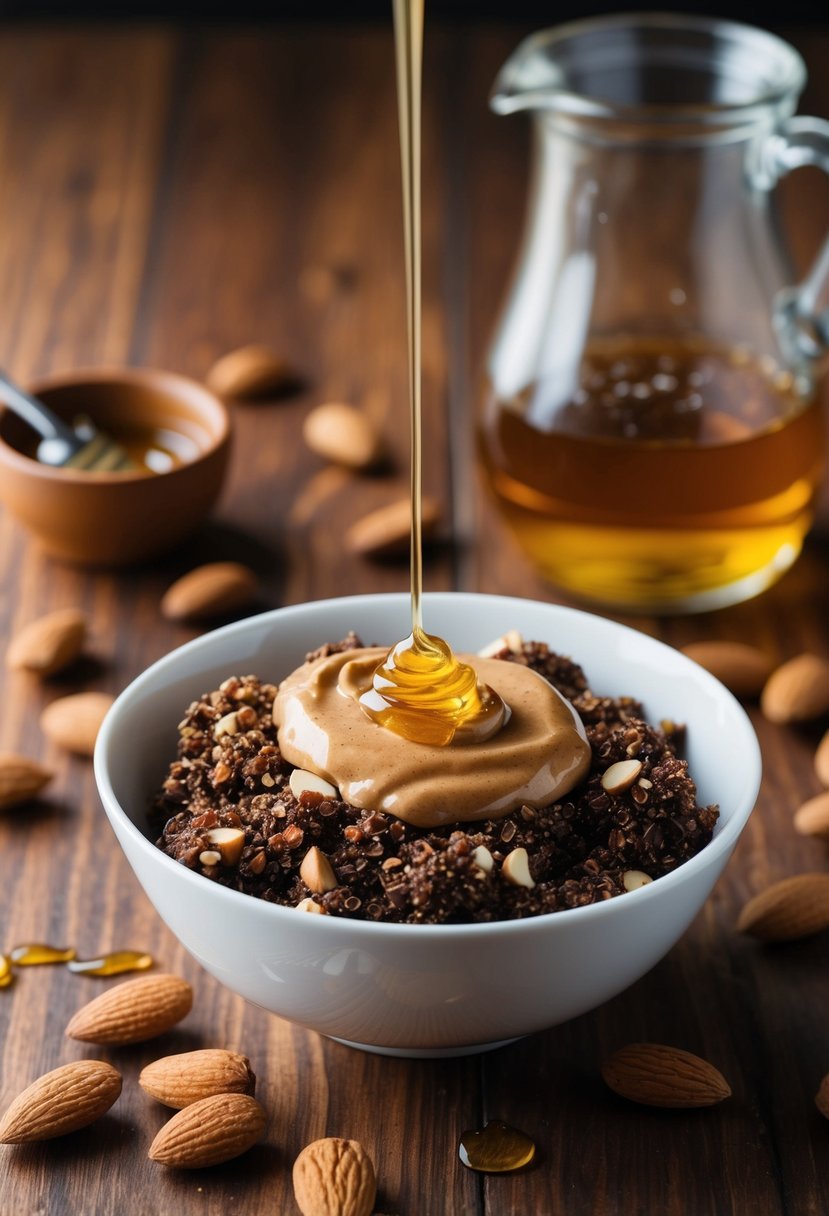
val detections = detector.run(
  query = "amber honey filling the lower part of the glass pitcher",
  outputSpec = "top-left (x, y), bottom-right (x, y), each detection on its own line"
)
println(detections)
top-left (480, 338), bottom-right (823, 610)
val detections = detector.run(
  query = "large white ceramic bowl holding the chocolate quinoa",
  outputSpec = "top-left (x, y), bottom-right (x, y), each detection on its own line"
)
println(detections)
top-left (95, 593), bottom-right (760, 1055)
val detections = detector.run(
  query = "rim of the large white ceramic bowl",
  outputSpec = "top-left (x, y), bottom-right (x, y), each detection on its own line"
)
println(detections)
top-left (94, 591), bottom-right (762, 944)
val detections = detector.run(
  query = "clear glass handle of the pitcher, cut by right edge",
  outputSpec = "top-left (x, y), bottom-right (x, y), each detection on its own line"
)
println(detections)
top-left (758, 114), bottom-right (829, 362)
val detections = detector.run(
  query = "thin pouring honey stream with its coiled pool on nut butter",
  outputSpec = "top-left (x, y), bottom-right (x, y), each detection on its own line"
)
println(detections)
top-left (360, 0), bottom-right (508, 745)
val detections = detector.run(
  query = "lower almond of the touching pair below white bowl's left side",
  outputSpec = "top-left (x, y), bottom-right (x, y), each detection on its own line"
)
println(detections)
top-left (148, 1093), bottom-right (267, 1170)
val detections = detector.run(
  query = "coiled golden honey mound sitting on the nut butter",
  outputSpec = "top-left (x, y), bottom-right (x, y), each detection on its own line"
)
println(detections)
top-left (360, 627), bottom-right (507, 747)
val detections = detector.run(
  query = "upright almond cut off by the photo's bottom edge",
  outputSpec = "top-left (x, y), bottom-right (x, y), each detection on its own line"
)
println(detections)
top-left (293, 1136), bottom-right (377, 1216)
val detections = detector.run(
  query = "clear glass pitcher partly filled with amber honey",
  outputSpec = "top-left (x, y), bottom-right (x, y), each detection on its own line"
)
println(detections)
top-left (479, 13), bottom-right (829, 612)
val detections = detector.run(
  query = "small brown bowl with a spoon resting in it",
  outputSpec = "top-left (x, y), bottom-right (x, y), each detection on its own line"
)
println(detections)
top-left (0, 367), bottom-right (230, 567)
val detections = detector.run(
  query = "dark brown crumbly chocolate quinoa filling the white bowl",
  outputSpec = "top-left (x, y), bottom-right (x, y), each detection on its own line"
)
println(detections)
top-left (151, 634), bottom-right (718, 924)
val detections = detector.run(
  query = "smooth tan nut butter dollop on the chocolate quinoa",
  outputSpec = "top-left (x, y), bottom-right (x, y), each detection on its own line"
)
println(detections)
top-left (273, 647), bottom-right (591, 828)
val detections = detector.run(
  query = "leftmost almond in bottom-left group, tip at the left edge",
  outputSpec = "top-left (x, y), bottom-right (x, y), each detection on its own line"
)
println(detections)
top-left (0, 1060), bottom-right (122, 1144)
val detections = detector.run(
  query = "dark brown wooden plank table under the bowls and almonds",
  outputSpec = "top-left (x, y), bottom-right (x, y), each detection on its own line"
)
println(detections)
top-left (0, 26), bottom-right (829, 1216)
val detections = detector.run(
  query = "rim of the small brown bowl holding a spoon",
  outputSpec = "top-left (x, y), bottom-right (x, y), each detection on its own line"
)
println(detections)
top-left (0, 364), bottom-right (231, 486)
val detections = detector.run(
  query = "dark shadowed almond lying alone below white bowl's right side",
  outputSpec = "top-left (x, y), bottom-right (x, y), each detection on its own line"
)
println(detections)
top-left (602, 1043), bottom-right (731, 1108)
